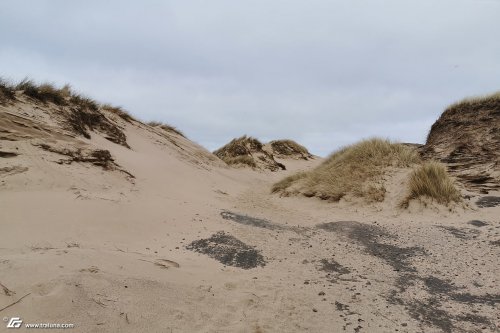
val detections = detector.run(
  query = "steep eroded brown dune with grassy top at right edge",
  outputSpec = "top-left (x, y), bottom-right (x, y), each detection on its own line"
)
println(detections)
top-left (424, 93), bottom-right (500, 194)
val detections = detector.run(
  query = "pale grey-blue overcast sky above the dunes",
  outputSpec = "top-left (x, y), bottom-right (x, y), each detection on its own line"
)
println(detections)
top-left (0, 0), bottom-right (500, 155)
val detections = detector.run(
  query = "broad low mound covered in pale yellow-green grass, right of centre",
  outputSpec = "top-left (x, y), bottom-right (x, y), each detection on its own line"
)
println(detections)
top-left (271, 138), bottom-right (421, 202)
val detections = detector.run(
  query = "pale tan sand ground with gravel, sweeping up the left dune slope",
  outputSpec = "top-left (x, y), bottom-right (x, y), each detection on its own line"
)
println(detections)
top-left (0, 100), bottom-right (500, 333)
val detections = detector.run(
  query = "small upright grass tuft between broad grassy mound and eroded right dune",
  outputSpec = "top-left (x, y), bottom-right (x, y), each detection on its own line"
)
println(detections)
top-left (401, 161), bottom-right (461, 207)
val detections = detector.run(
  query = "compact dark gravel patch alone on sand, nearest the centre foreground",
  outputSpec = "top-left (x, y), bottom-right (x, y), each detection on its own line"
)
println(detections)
top-left (186, 231), bottom-right (266, 269)
